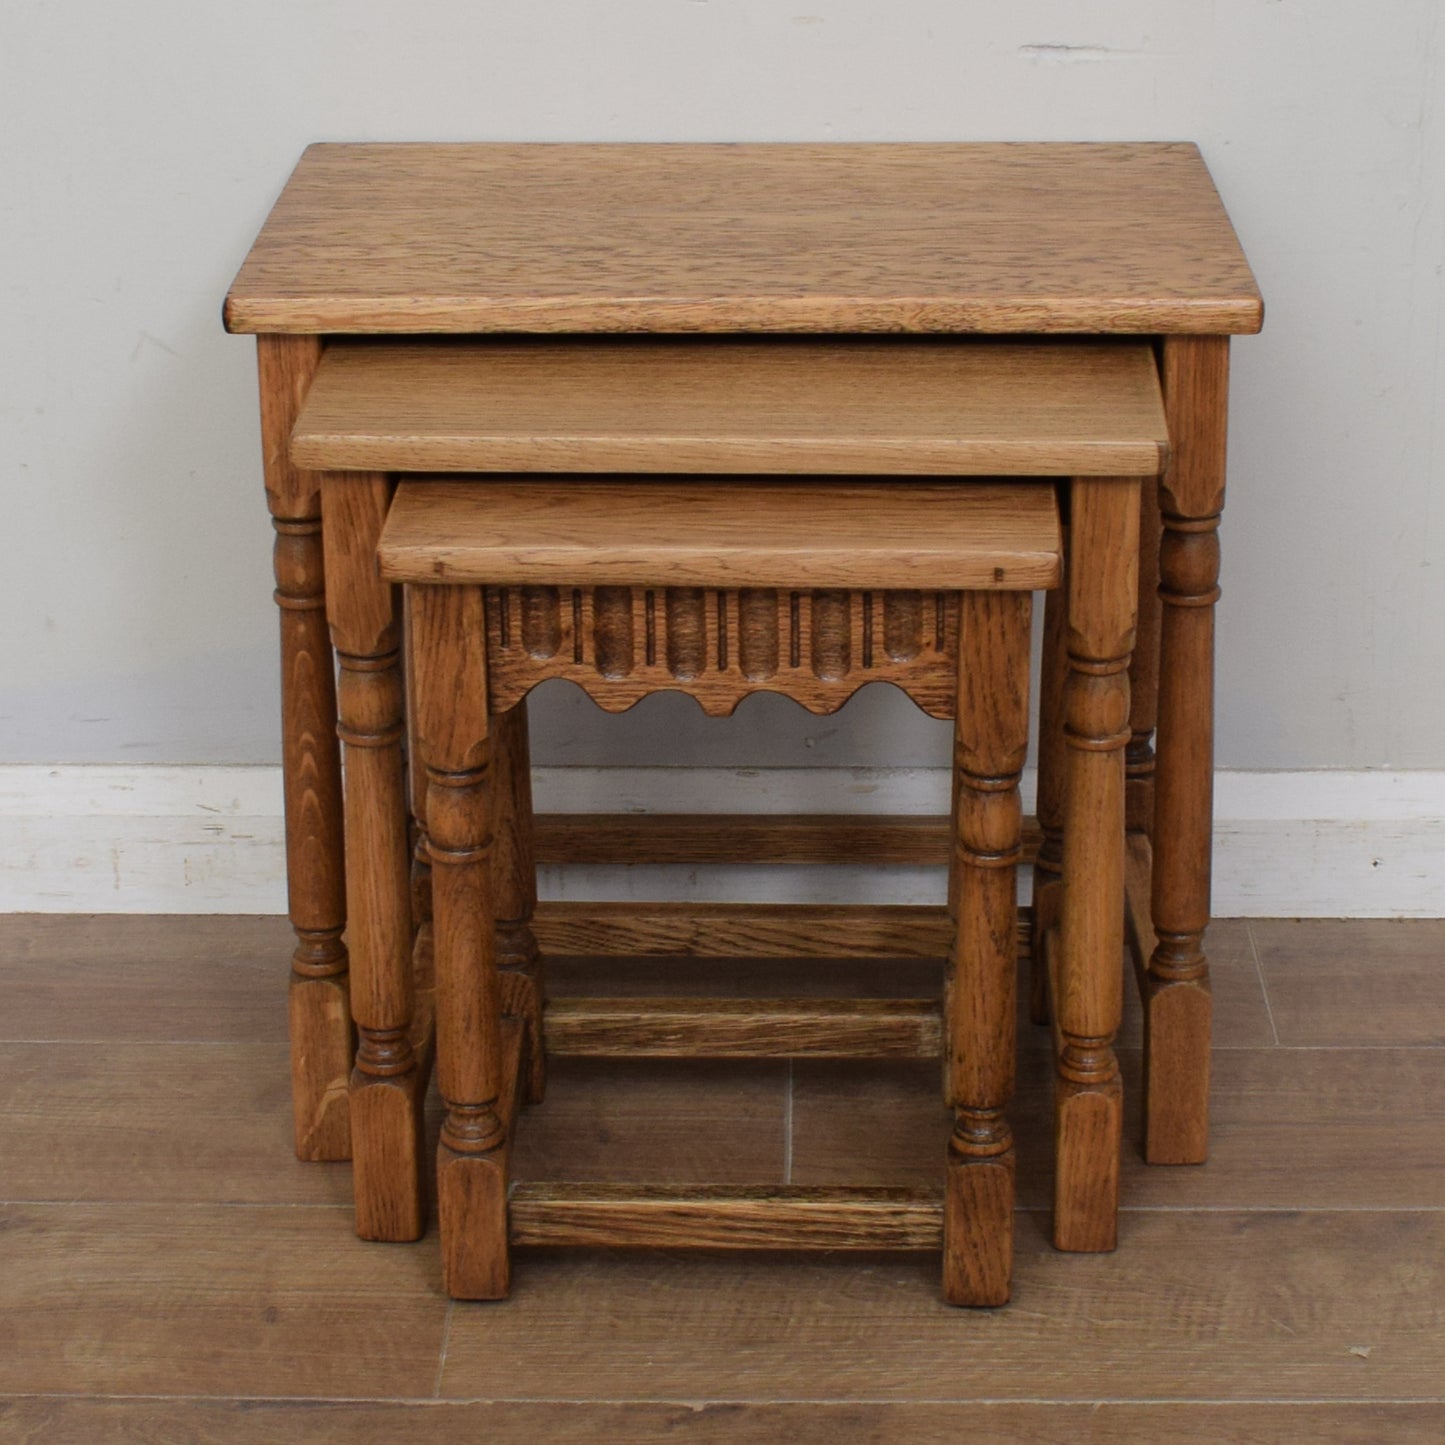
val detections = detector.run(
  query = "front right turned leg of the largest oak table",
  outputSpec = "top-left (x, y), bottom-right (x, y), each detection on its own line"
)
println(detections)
top-left (1144, 337), bottom-right (1230, 1163)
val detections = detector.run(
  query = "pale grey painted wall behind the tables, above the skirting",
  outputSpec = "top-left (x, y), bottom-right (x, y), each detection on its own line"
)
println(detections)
top-left (0, 0), bottom-right (1445, 769)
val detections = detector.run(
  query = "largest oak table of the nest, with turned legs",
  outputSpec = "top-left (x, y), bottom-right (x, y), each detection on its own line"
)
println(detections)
top-left (225, 143), bottom-right (1263, 1248)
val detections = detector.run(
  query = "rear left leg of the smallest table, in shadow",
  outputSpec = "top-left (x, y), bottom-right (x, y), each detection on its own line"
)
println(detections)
top-left (491, 699), bottom-right (546, 1104)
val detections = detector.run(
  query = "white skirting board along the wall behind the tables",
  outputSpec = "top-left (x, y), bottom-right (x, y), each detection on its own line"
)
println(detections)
top-left (0, 766), bottom-right (1445, 918)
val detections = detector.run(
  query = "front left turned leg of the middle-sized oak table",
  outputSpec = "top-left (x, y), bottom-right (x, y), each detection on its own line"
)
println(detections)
top-left (322, 473), bottom-right (425, 1240)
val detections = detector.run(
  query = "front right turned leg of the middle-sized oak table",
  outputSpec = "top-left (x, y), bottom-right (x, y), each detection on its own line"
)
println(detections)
top-left (1053, 477), bottom-right (1139, 1250)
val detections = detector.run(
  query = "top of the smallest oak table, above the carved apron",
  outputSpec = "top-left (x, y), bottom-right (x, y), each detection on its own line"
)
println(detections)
top-left (379, 478), bottom-right (1061, 592)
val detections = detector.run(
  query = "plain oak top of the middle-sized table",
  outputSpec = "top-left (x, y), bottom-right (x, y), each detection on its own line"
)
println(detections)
top-left (290, 338), bottom-right (1168, 476)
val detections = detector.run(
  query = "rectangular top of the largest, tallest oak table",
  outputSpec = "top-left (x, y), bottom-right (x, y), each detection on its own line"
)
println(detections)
top-left (225, 142), bottom-right (1263, 334)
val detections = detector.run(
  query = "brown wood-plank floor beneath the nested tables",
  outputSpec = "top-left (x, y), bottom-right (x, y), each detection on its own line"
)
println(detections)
top-left (0, 916), bottom-right (1445, 1445)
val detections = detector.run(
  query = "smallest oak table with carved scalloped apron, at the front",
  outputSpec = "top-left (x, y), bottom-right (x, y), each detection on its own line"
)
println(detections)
top-left (395, 481), bottom-right (1061, 1305)
